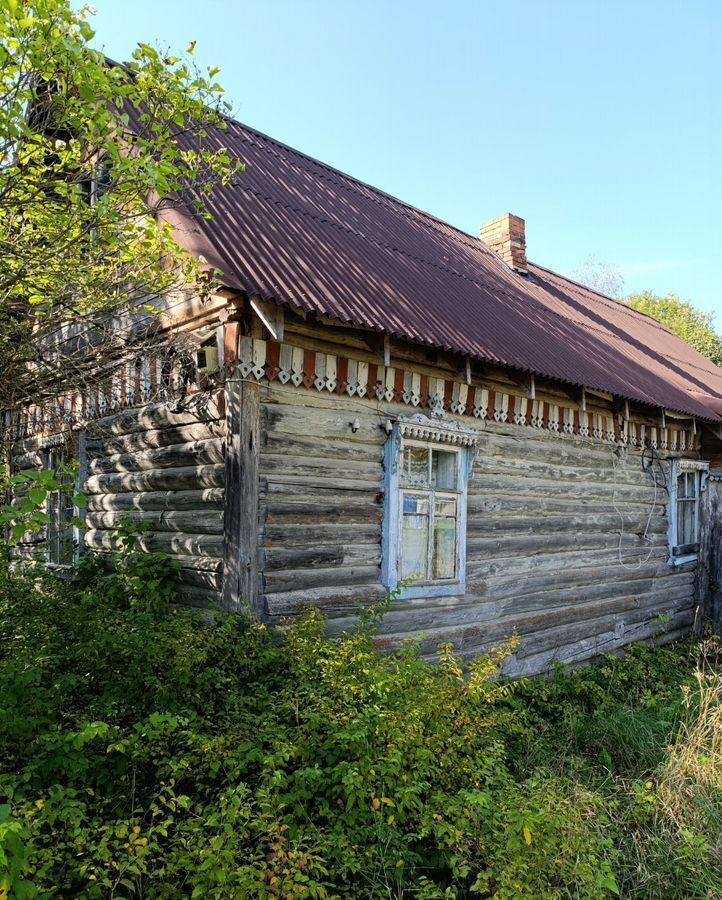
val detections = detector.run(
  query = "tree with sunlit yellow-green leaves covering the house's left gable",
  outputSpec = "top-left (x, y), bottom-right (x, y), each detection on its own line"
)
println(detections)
top-left (0, 0), bottom-right (242, 418)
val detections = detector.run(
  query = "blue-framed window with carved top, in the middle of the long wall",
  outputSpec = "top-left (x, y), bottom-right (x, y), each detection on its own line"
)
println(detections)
top-left (383, 416), bottom-right (478, 597)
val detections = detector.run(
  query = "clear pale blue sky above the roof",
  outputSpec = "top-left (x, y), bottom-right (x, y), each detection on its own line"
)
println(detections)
top-left (81, 0), bottom-right (722, 327)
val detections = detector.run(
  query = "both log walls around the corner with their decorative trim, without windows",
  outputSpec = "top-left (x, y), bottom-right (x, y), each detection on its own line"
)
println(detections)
top-left (5, 307), bottom-right (699, 674)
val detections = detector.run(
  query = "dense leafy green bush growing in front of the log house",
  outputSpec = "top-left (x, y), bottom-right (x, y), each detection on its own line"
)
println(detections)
top-left (0, 546), bottom-right (615, 900)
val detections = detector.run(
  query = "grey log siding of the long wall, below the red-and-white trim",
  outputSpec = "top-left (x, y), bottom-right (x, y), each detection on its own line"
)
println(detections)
top-left (258, 384), bottom-right (694, 673)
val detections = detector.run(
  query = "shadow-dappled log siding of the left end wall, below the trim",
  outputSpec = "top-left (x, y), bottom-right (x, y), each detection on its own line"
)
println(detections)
top-left (85, 392), bottom-right (226, 604)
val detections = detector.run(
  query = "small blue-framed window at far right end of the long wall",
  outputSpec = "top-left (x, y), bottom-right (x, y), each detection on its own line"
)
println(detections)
top-left (669, 459), bottom-right (709, 566)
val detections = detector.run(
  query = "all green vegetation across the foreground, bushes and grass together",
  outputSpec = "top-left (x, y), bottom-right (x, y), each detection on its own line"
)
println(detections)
top-left (0, 529), bottom-right (722, 900)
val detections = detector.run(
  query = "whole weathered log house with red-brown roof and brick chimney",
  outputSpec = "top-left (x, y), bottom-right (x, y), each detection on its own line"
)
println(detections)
top-left (6, 116), bottom-right (722, 673)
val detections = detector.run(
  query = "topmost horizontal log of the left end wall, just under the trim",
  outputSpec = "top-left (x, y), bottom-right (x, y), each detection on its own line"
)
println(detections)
top-left (87, 391), bottom-right (225, 441)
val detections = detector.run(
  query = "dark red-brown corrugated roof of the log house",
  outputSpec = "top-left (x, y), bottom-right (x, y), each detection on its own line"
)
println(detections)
top-left (170, 121), bottom-right (722, 421)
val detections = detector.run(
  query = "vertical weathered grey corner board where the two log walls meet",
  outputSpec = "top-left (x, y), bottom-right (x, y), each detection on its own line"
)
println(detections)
top-left (223, 378), bottom-right (262, 616)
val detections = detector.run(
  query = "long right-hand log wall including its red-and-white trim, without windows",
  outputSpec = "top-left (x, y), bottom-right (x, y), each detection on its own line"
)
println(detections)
top-left (248, 314), bottom-right (699, 674)
